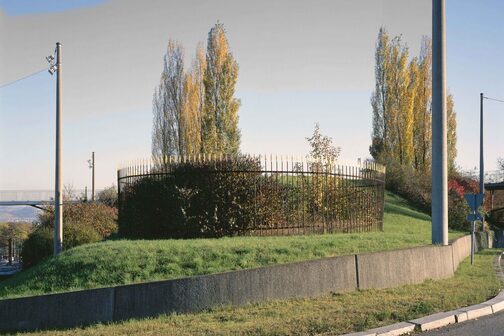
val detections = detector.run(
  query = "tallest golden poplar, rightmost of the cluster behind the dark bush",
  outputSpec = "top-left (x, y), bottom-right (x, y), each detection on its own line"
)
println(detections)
top-left (202, 23), bottom-right (240, 154)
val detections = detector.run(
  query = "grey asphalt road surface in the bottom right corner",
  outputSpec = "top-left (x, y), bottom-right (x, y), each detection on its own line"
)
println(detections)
top-left (421, 312), bottom-right (504, 336)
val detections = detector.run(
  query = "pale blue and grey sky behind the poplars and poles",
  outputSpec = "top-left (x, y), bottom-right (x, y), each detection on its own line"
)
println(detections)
top-left (0, 0), bottom-right (504, 190)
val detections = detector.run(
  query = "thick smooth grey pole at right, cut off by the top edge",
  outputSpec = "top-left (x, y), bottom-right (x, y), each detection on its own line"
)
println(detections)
top-left (432, 0), bottom-right (448, 245)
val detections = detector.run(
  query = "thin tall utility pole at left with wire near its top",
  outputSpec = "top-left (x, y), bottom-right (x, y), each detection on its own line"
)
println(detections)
top-left (54, 42), bottom-right (63, 255)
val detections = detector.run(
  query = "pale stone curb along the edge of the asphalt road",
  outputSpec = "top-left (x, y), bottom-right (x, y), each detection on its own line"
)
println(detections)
top-left (342, 252), bottom-right (504, 336)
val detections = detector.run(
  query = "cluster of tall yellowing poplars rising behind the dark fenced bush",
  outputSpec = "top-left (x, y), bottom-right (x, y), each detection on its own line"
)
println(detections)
top-left (152, 23), bottom-right (240, 165)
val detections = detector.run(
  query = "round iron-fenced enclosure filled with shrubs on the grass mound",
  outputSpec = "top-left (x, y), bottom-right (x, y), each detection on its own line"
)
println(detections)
top-left (118, 155), bottom-right (385, 238)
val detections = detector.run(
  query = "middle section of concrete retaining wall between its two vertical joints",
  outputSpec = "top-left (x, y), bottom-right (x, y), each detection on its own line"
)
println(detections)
top-left (114, 256), bottom-right (357, 320)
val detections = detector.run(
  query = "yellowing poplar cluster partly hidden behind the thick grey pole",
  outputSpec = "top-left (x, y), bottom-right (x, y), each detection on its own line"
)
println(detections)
top-left (370, 28), bottom-right (457, 173)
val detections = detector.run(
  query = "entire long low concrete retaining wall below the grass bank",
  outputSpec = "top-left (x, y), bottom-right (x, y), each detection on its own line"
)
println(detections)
top-left (0, 236), bottom-right (478, 332)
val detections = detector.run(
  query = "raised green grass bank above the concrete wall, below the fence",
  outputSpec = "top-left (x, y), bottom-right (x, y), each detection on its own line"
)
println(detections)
top-left (0, 193), bottom-right (463, 298)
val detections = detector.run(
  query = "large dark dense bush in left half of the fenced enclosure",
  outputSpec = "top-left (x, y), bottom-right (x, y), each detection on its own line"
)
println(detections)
top-left (119, 157), bottom-right (267, 238)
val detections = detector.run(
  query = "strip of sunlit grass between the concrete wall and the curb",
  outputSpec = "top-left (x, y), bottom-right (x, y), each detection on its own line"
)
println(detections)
top-left (13, 250), bottom-right (502, 336)
